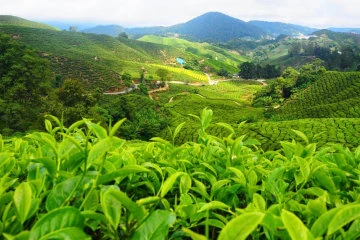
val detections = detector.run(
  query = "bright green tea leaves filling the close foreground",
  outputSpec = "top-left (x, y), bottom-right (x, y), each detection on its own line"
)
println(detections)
top-left (0, 109), bottom-right (360, 239)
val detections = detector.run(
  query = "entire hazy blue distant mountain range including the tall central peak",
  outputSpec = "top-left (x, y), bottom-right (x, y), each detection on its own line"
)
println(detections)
top-left (79, 12), bottom-right (360, 42)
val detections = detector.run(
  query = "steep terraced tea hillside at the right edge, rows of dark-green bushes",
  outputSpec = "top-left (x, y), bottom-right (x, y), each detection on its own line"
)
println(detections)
top-left (278, 71), bottom-right (360, 119)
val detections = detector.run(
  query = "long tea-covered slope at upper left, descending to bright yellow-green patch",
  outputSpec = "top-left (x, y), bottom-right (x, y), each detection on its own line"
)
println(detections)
top-left (0, 19), bottom-right (225, 90)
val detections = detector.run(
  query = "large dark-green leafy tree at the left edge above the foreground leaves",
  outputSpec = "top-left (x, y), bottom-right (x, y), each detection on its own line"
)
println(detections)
top-left (0, 34), bottom-right (51, 131)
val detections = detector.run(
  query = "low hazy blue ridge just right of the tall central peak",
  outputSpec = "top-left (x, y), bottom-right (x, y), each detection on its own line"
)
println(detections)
top-left (249, 20), bottom-right (318, 37)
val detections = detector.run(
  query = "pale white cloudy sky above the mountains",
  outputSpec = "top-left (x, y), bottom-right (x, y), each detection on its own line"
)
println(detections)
top-left (0, 0), bottom-right (360, 28)
